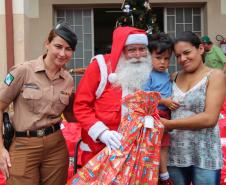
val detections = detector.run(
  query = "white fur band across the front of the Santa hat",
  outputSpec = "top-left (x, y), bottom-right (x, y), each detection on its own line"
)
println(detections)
top-left (125, 34), bottom-right (148, 46)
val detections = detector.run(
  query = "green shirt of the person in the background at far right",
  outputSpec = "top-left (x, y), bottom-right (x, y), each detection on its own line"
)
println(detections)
top-left (205, 45), bottom-right (226, 69)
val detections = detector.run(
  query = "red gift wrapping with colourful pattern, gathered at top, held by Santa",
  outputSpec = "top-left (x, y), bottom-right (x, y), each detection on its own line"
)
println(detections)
top-left (67, 91), bottom-right (163, 185)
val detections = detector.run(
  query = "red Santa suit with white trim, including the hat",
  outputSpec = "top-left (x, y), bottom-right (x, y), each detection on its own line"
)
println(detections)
top-left (73, 27), bottom-right (147, 165)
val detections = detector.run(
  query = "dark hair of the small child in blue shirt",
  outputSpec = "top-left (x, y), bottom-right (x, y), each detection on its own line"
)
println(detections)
top-left (148, 32), bottom-right (173, 54)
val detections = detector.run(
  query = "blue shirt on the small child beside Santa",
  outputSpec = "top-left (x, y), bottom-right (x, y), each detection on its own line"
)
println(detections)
top-left (143, 70), bottom-right (172, 110)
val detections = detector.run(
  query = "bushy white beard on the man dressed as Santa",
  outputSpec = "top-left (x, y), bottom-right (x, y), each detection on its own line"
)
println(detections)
top-left (115, 54), bottom-right (152, 93)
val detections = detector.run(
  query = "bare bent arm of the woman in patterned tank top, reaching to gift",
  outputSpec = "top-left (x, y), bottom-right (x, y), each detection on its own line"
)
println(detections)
top-left (161, 70), bottom-right (226, 130)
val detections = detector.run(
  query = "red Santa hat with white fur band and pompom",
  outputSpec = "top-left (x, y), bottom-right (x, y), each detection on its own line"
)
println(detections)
top-left (109, 26), bottom-right (148, 83)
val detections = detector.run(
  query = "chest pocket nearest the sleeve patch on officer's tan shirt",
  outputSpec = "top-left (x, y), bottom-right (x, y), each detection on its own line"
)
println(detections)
top-left (22, 88), bottom-right (42, 113)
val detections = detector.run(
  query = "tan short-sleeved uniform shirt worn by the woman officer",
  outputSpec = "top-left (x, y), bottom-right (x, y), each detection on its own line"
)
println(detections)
top-left (0, 56), bottom-right (74, 131)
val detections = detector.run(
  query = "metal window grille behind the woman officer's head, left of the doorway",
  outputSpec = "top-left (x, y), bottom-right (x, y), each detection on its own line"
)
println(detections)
top-left (54, 8), bottom-right (94, 87)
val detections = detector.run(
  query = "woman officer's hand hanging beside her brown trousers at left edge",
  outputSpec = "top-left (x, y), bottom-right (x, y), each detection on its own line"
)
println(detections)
top-left (0, 147), bottom-right (11, 179)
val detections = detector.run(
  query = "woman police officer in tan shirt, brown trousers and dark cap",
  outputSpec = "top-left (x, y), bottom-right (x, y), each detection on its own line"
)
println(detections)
top-left (0, 23), bottom-right (77, 185)
